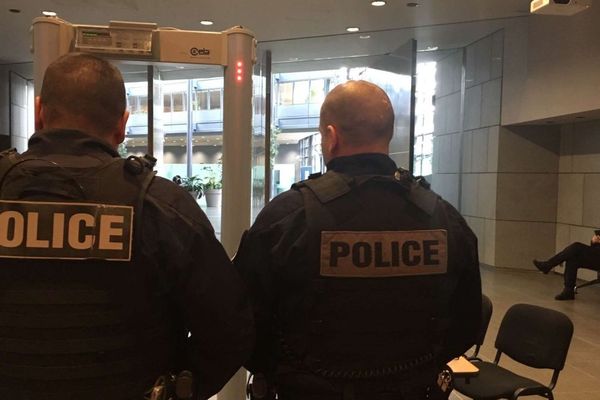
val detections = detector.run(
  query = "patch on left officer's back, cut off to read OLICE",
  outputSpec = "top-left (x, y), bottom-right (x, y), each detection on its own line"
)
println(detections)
top-left (0, 200), bottom-right (133, 261)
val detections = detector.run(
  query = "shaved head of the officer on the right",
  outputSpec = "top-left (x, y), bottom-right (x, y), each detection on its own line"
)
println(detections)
top-left (319, 81), bottom-right (394, 163)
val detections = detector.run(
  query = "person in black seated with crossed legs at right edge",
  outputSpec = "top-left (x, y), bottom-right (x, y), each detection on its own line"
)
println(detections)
top-left (533, 230), bottom-right (600, 300)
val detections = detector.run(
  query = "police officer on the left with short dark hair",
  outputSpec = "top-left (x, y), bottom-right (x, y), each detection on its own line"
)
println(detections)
top-left (0, 54), bottom-right (254, 400)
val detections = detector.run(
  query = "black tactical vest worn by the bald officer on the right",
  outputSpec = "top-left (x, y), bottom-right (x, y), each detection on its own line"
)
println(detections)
top-left (279, 171), bottom-right (451, 392)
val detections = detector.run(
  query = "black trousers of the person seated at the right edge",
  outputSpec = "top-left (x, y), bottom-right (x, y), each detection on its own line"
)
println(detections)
top-left (547, 242), bottom-right (600, 288)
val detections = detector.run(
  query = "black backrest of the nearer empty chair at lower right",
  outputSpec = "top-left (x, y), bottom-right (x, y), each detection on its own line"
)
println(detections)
top-left (495, 304), bottom-right (573, 371)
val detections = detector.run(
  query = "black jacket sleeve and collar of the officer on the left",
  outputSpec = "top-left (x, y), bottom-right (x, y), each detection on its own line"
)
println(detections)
top-left (15, 130), bottom-right (254, 398)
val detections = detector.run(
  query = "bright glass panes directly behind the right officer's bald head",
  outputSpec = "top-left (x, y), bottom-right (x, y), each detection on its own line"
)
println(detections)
top-left (264, 58), bottom-right (411, 197)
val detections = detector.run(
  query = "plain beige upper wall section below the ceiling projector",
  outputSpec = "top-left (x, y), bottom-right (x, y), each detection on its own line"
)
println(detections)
top-left (502, 8), bottom-right (600, 125)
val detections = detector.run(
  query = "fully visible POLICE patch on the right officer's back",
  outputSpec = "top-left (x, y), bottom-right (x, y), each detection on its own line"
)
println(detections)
top-left (321, 229), bottom-right (448, 278)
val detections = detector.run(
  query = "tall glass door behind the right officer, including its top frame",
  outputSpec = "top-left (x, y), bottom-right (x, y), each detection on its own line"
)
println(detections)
top-left (259, 31), bottom-right (417, 197)
